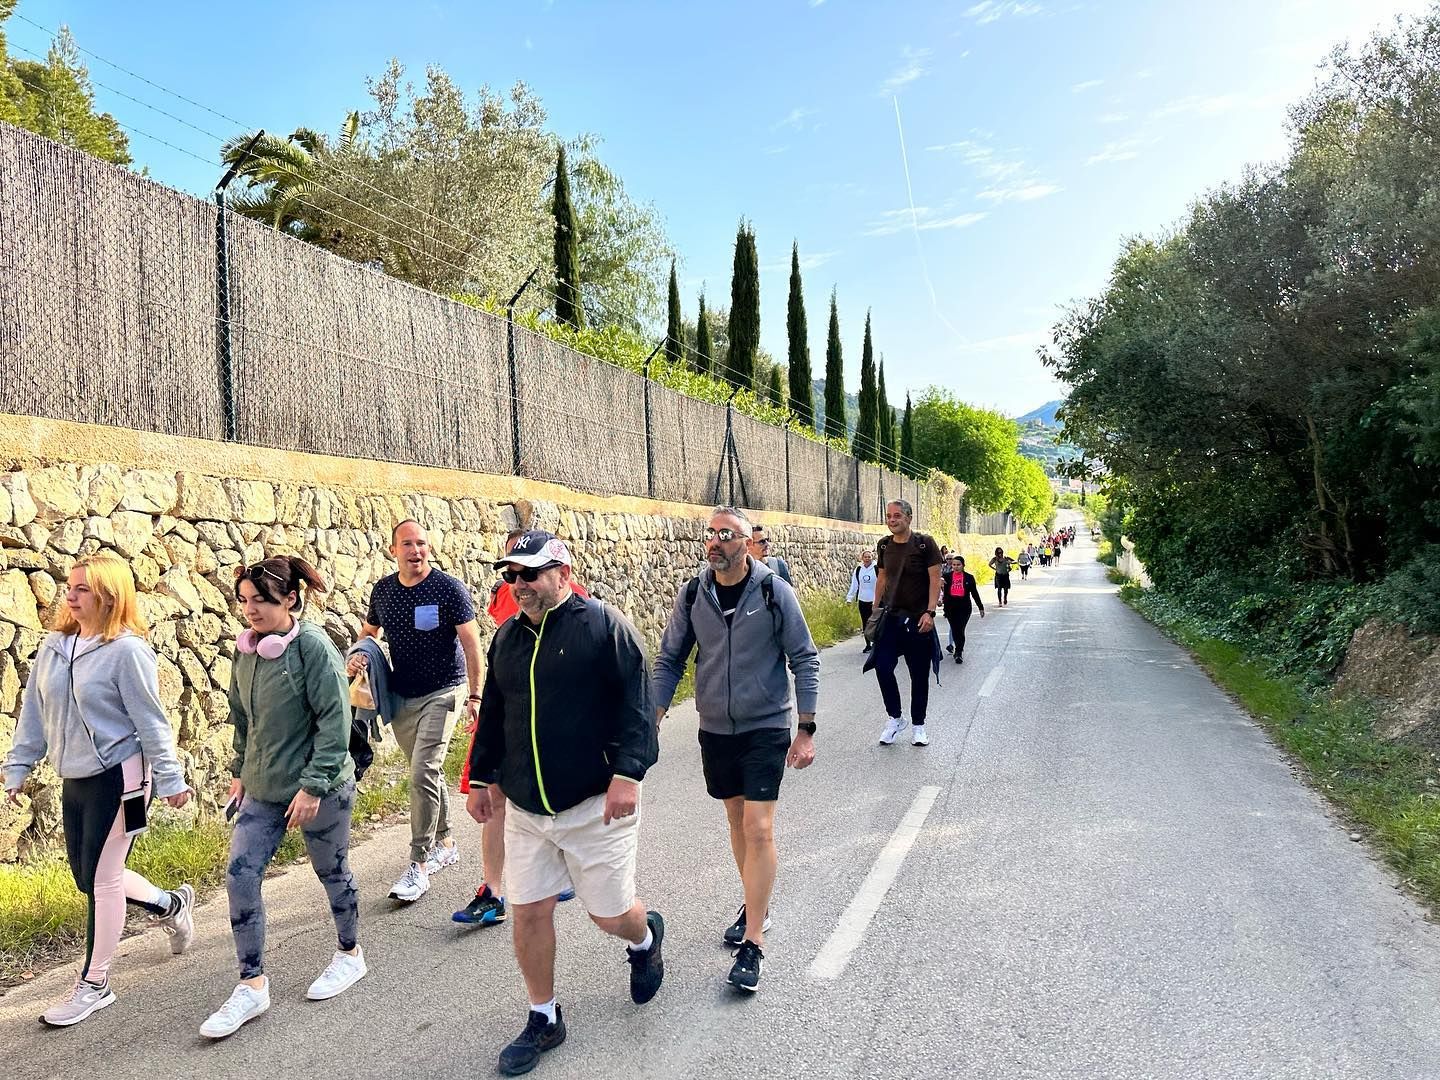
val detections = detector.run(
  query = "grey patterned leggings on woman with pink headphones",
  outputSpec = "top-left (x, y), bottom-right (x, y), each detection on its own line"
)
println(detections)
top-left (225, 780), bottom-right (360, 979)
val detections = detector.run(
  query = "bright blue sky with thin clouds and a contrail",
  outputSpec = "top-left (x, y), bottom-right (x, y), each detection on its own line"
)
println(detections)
top-left (7, 0), bottom-right (1427, 413)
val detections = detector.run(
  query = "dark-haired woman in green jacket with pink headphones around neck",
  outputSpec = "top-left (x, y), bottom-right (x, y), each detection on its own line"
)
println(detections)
top-left (200, 556), bottom-right (366, 1038)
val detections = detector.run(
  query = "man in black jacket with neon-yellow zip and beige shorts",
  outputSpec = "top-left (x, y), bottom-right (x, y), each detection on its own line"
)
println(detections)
top-left (467, 530), bottom-right (665, 1076)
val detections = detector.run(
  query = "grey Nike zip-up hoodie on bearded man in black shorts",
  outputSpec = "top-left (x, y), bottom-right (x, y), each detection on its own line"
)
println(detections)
top-left (655, 559), bottom-right (819, 734)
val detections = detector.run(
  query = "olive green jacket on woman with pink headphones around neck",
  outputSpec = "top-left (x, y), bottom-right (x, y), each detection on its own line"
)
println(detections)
top-left (230, 621), bottom-right (356, 804)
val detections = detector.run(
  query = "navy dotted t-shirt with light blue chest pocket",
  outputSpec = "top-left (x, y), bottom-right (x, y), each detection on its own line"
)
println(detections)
top-left (364, 567), bottom-right (475, 697)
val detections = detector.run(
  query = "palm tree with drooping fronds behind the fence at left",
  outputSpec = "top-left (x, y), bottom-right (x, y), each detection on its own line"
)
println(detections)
top-left (220, 112), bottom-right (360, 248)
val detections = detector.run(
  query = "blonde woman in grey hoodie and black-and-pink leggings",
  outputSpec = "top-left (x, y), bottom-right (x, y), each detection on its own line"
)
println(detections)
top-left (4, 553), bottom-right (194, 1027)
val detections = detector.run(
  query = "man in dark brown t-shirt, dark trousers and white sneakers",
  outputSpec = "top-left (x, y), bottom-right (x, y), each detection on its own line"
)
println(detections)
top-left (865, 500), bottom-right (940, 746)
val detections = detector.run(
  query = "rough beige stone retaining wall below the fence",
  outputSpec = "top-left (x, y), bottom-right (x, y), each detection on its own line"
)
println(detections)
top-left (0, 448), bottom-right (881, 861)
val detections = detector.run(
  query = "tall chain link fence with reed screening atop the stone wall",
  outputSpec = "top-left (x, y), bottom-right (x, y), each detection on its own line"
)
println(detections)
top-left (0, 124), bottom-right (927, 527)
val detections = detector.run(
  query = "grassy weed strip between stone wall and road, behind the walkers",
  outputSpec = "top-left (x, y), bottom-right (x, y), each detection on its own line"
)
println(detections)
top-left (0, 590), bottom-right (860, 988)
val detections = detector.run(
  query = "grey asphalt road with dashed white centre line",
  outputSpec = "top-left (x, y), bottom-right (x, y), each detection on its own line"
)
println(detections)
top-left (0, 518), bottom-right (1440, 1080)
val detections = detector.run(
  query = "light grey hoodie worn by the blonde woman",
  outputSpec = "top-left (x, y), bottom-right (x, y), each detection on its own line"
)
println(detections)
top-left (4, 631), bottom-right (186, 798)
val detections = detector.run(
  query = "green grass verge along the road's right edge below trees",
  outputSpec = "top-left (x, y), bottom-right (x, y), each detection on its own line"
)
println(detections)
top-left (1120, 585), bottom-right (1440, 910)
